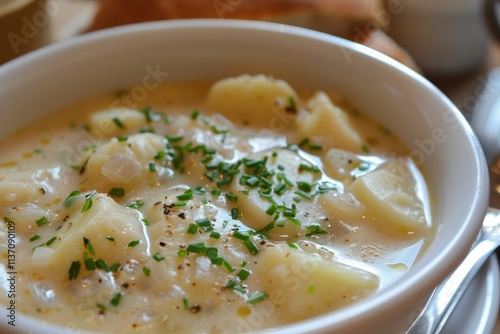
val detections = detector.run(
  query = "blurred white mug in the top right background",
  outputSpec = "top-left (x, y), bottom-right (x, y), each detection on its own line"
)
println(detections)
top-left (386, 0), bottom-right (500, 76)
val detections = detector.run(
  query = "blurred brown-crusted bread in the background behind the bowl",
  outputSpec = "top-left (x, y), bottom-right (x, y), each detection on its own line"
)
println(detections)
top-left (88, 0), bottom-right (420, 72)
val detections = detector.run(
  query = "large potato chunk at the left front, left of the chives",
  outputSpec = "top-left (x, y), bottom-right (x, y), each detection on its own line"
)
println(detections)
top-left (32, 194), bottom-right (148, 279)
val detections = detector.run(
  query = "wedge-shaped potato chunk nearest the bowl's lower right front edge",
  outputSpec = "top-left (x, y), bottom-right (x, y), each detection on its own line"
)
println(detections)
top-left (255, 244), bottom-right (379, 320)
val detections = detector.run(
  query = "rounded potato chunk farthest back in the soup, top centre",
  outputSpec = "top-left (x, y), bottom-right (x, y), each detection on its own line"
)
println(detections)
top-left (206, 75), bottom-right (297, 131)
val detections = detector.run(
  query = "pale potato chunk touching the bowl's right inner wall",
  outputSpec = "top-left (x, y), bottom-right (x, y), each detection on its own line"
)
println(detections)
top-left (351, 159), bottom-right (427, 230)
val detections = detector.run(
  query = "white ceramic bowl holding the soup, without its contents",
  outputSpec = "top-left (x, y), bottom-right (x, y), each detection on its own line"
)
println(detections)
top-left (0, 20), bottom-right (488, 333)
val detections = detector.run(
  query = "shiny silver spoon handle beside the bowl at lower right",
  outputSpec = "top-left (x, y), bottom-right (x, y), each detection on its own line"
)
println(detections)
top-left (406, 209), bottom-right (500, 334)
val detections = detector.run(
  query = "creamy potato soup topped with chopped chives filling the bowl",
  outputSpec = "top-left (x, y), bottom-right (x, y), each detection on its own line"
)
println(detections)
top-left (0, 75), bottom-right (432, 333)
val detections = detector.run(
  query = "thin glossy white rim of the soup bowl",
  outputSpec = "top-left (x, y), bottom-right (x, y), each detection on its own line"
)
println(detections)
top-left (0, 19), bottom-right (488, 333)
